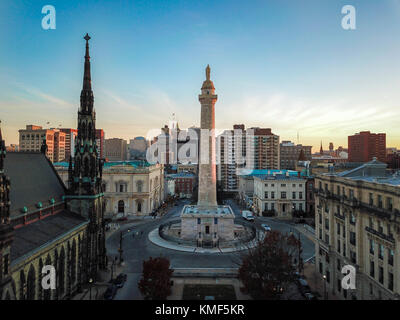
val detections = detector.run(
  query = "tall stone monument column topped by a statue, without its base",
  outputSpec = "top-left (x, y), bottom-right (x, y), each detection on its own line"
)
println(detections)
top-left (197, 65), bottom-right (217, 207)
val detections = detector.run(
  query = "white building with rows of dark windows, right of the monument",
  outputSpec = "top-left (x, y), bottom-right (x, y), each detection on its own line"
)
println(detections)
top-left (253, 172), bottom-right (306, 219)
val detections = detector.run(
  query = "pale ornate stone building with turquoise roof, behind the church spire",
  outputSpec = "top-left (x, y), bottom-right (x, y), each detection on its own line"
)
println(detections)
top-left (54, 161), bottom-right (164, 218)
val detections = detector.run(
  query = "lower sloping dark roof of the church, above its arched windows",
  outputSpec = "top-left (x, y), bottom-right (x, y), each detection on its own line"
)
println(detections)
top-left (11, 211), bottom-right (88, 262)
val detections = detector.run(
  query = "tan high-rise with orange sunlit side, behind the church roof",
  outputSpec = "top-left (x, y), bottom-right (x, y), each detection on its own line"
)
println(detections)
top-left (19, 125), bottom-right (65, 162)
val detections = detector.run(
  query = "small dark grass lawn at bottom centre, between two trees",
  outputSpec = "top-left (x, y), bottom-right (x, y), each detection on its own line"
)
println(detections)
top-left (182, 284), bottom-right (236, 300)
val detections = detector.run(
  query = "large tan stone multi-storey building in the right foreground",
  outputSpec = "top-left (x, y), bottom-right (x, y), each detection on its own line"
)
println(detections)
top-left (315, 159), bottom-right (400, 300)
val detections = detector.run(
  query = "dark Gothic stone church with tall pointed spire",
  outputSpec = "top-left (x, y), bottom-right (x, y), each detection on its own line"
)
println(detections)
top-left (0, 34), bottom-right (107, 300)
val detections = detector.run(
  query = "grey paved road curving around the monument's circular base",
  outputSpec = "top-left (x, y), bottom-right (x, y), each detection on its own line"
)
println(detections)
top-left (106, 201), bottom-right (314, 300)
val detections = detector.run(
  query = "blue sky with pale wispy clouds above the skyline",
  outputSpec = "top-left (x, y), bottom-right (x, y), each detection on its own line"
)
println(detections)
top-left (0, 0), bottom-right (400, 152)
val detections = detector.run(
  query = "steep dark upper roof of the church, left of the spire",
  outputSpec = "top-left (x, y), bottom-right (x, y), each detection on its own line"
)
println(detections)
top-left (4, 152), bottom-right (66, 219)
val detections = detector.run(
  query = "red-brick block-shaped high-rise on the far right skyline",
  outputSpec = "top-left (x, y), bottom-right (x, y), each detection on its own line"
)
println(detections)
top-left (348, 131), bottom-right (386, 162)
